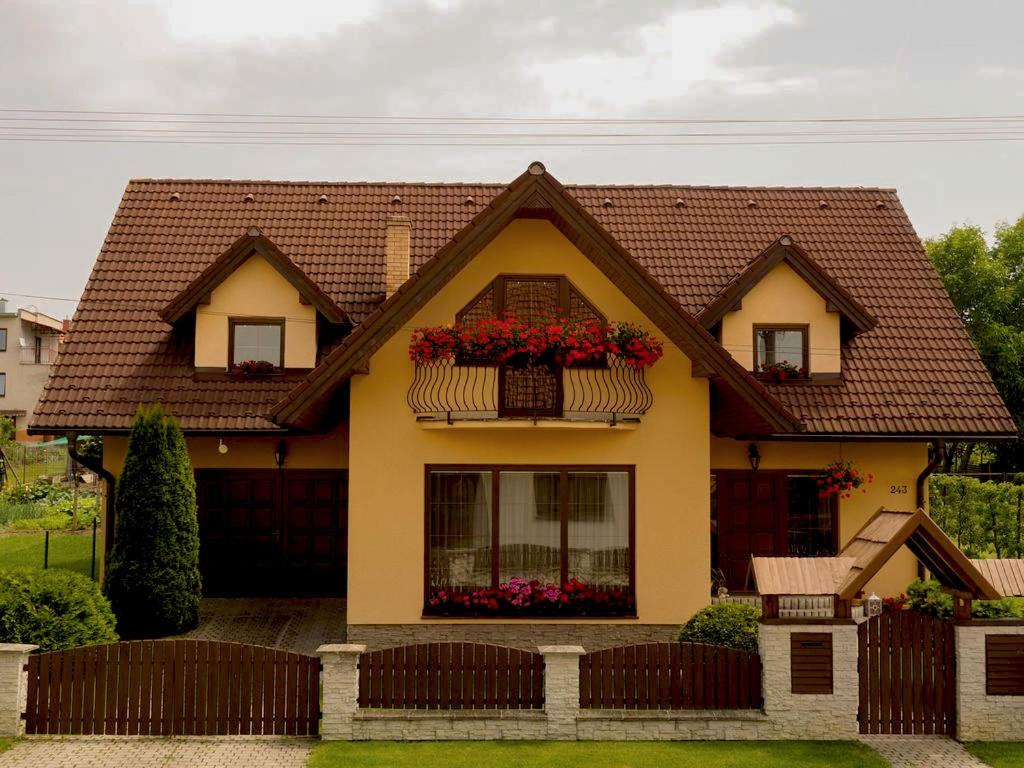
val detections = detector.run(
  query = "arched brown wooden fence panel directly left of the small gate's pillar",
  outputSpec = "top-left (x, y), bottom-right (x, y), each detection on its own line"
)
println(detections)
top-left (580, 643), bottom-right (762, 710)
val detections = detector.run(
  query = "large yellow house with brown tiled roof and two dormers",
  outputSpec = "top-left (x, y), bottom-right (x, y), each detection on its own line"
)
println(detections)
top-left (33, 163), bottom-right (1015, 644)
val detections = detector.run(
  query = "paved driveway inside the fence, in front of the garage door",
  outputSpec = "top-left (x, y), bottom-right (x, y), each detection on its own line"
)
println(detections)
top-left (184, 597), bottom-right (347, 653)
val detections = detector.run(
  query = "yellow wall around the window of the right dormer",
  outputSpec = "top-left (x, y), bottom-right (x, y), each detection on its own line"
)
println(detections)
top-left (722, 262), bottom-right (840, 375)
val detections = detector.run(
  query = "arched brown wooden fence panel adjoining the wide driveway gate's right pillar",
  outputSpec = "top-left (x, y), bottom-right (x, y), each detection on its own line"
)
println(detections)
top-left (359, 643), bottom-right (544, 710)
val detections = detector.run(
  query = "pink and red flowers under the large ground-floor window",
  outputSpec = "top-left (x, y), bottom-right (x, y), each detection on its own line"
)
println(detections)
top-left (424, 577), bottom-right (636, 616)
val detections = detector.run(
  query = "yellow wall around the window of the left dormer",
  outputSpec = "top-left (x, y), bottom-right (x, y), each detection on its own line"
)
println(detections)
top-left (196, 255), bottom-right (316, 368)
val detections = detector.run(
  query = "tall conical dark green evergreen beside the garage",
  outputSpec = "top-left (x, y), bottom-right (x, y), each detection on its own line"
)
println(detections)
top-left (106, 406), bottom-right (200, 638)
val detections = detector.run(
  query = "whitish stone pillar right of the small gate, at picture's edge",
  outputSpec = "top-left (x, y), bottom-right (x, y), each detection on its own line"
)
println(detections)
top-left (956, 620), bottom-right (1024, 741)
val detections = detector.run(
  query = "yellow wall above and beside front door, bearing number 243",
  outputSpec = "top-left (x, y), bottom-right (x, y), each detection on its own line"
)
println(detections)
top-left (711, 437), bottom-right (928, 596)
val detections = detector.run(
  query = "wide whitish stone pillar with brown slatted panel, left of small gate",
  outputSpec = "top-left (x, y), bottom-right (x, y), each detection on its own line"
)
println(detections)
top-left (758, 618), bottom-right (859, 739)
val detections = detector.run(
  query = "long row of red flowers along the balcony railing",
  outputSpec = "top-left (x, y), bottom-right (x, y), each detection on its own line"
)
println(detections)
top-left (409, 316), bottom-right (665, 369)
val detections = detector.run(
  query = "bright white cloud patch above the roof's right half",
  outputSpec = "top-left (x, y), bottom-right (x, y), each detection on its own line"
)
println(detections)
top-left (527, 3), bottom-right (798, 114)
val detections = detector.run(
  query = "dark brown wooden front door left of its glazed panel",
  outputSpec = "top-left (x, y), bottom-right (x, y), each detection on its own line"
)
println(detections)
top-left (715, 470), bottom-right (786, 590)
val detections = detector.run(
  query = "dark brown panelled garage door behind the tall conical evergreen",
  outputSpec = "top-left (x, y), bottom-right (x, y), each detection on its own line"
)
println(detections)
top-left (196, 469), bottom-right (348, 595)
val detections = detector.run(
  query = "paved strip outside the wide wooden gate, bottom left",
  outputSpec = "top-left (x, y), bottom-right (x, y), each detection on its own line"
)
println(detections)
top-left (0, 736), bottom-right (314, 768)
